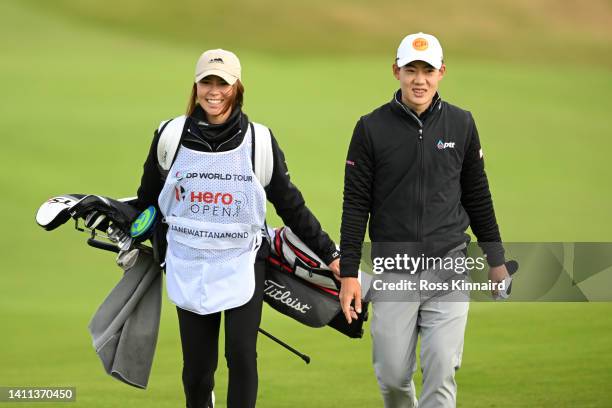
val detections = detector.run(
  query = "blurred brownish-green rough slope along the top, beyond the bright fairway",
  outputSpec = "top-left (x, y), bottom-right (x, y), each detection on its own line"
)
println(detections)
top-left (16, 0), bottom-right (612, 68)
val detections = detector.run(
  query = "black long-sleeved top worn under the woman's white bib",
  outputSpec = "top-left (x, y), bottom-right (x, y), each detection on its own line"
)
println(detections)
top-left (136, 106), bottom-right (339, 264)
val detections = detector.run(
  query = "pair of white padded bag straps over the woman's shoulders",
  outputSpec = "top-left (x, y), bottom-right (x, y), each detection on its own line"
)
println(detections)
top-left (157, 115), bottom-right (274, 187)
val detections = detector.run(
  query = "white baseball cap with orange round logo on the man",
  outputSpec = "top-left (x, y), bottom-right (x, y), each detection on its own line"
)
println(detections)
top-left (395, 33), bottom-right (444, 69)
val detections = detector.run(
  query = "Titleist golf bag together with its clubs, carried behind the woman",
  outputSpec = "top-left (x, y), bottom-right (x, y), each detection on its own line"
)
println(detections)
top-left (36, 194), bottom-right (371, 338)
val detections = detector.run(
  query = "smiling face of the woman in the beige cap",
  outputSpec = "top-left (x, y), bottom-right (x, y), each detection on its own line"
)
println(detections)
top-left (196, 75), bottom-right (234, 124)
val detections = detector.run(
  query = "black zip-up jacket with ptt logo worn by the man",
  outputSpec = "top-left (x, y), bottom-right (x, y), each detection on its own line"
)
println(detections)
top-left (340, 91), bottom-right (504, 276)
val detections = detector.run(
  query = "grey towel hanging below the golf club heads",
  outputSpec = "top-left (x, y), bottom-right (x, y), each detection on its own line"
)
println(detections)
top-left (89, 250), bottom-right (162, 389)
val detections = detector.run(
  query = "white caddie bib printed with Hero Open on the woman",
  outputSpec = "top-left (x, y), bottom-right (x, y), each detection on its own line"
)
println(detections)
top-left (158, 126), bottom-right (266, 314)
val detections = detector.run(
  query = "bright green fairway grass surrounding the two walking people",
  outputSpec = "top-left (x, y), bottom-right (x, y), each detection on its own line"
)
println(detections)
top-left (0, 1), bottom-right (612, 408)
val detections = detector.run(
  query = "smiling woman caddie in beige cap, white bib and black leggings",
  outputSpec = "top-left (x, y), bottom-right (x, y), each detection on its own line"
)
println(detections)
top-left (133, 49), bottom-right (339, 408)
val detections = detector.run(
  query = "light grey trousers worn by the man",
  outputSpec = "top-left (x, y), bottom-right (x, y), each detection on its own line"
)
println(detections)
top-left (371, 296), bottom-right (469, 408)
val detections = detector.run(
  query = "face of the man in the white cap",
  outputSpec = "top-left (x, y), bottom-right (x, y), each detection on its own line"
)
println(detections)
top-left (393, 61), bottom-right (446, 115)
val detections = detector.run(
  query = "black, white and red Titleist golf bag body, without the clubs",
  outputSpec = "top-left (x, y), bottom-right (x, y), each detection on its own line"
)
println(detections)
top-left (264, 227), bottom-right (371, 338)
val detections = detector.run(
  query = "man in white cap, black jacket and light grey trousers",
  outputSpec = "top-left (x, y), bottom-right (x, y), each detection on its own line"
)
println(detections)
top-left (340, 33), bottom-right (508, 408)
